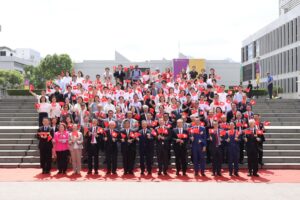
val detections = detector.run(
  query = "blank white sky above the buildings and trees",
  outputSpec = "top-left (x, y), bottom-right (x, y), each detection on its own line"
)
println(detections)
top-left (0, 0), bottom-right (279, 62)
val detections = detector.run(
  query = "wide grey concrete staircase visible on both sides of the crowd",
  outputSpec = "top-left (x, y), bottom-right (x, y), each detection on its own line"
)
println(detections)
top-left (0, 97), bottom-right (300, 169)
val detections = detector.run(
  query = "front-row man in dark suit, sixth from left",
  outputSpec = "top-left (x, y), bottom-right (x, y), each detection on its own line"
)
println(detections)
top-left (120, 119), bottom-right (136, 175)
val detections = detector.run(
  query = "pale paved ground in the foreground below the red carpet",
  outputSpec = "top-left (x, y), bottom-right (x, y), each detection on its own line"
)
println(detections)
top-left (0, 182), bottom-right (300, 200)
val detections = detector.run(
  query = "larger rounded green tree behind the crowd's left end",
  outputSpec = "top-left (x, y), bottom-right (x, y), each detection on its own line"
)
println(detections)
top-left (25, 54), bottom-right (73, 89)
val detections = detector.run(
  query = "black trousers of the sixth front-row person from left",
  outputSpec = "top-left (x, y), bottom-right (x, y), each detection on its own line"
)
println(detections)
top-left (122, 145), bottom-right (136, 173)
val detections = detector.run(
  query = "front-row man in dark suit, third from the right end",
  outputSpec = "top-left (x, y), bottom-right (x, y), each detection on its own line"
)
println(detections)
top-left (209, 121), bottom-right (223, 176)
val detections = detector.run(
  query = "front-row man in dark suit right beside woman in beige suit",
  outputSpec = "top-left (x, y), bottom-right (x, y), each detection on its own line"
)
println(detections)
top-left (86, 119), bottom-right (101, 174)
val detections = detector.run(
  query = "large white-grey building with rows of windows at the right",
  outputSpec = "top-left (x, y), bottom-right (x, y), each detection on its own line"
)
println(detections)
top-left (241, 0), bottom-right (300, 98)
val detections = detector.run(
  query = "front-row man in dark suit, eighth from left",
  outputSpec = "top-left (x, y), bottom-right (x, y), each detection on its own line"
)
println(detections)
top-left (155, 118), bottom-right (171, 175)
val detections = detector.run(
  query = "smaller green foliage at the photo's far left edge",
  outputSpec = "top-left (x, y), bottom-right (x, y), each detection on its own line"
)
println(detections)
top-left (0, 70), bottom-right (24, 89)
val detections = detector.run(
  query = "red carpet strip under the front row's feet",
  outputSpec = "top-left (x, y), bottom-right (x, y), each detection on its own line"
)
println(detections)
top-left (0, 168), bottom-right (300, 183)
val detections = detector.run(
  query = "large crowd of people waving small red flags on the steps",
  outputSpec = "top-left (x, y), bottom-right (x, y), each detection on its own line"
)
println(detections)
top-left (31, 65), bottom-right (268, 176)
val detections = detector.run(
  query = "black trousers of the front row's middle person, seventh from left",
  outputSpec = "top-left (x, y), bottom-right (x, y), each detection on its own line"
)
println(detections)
top-left (139, 146), bottom-right (153, 173)
